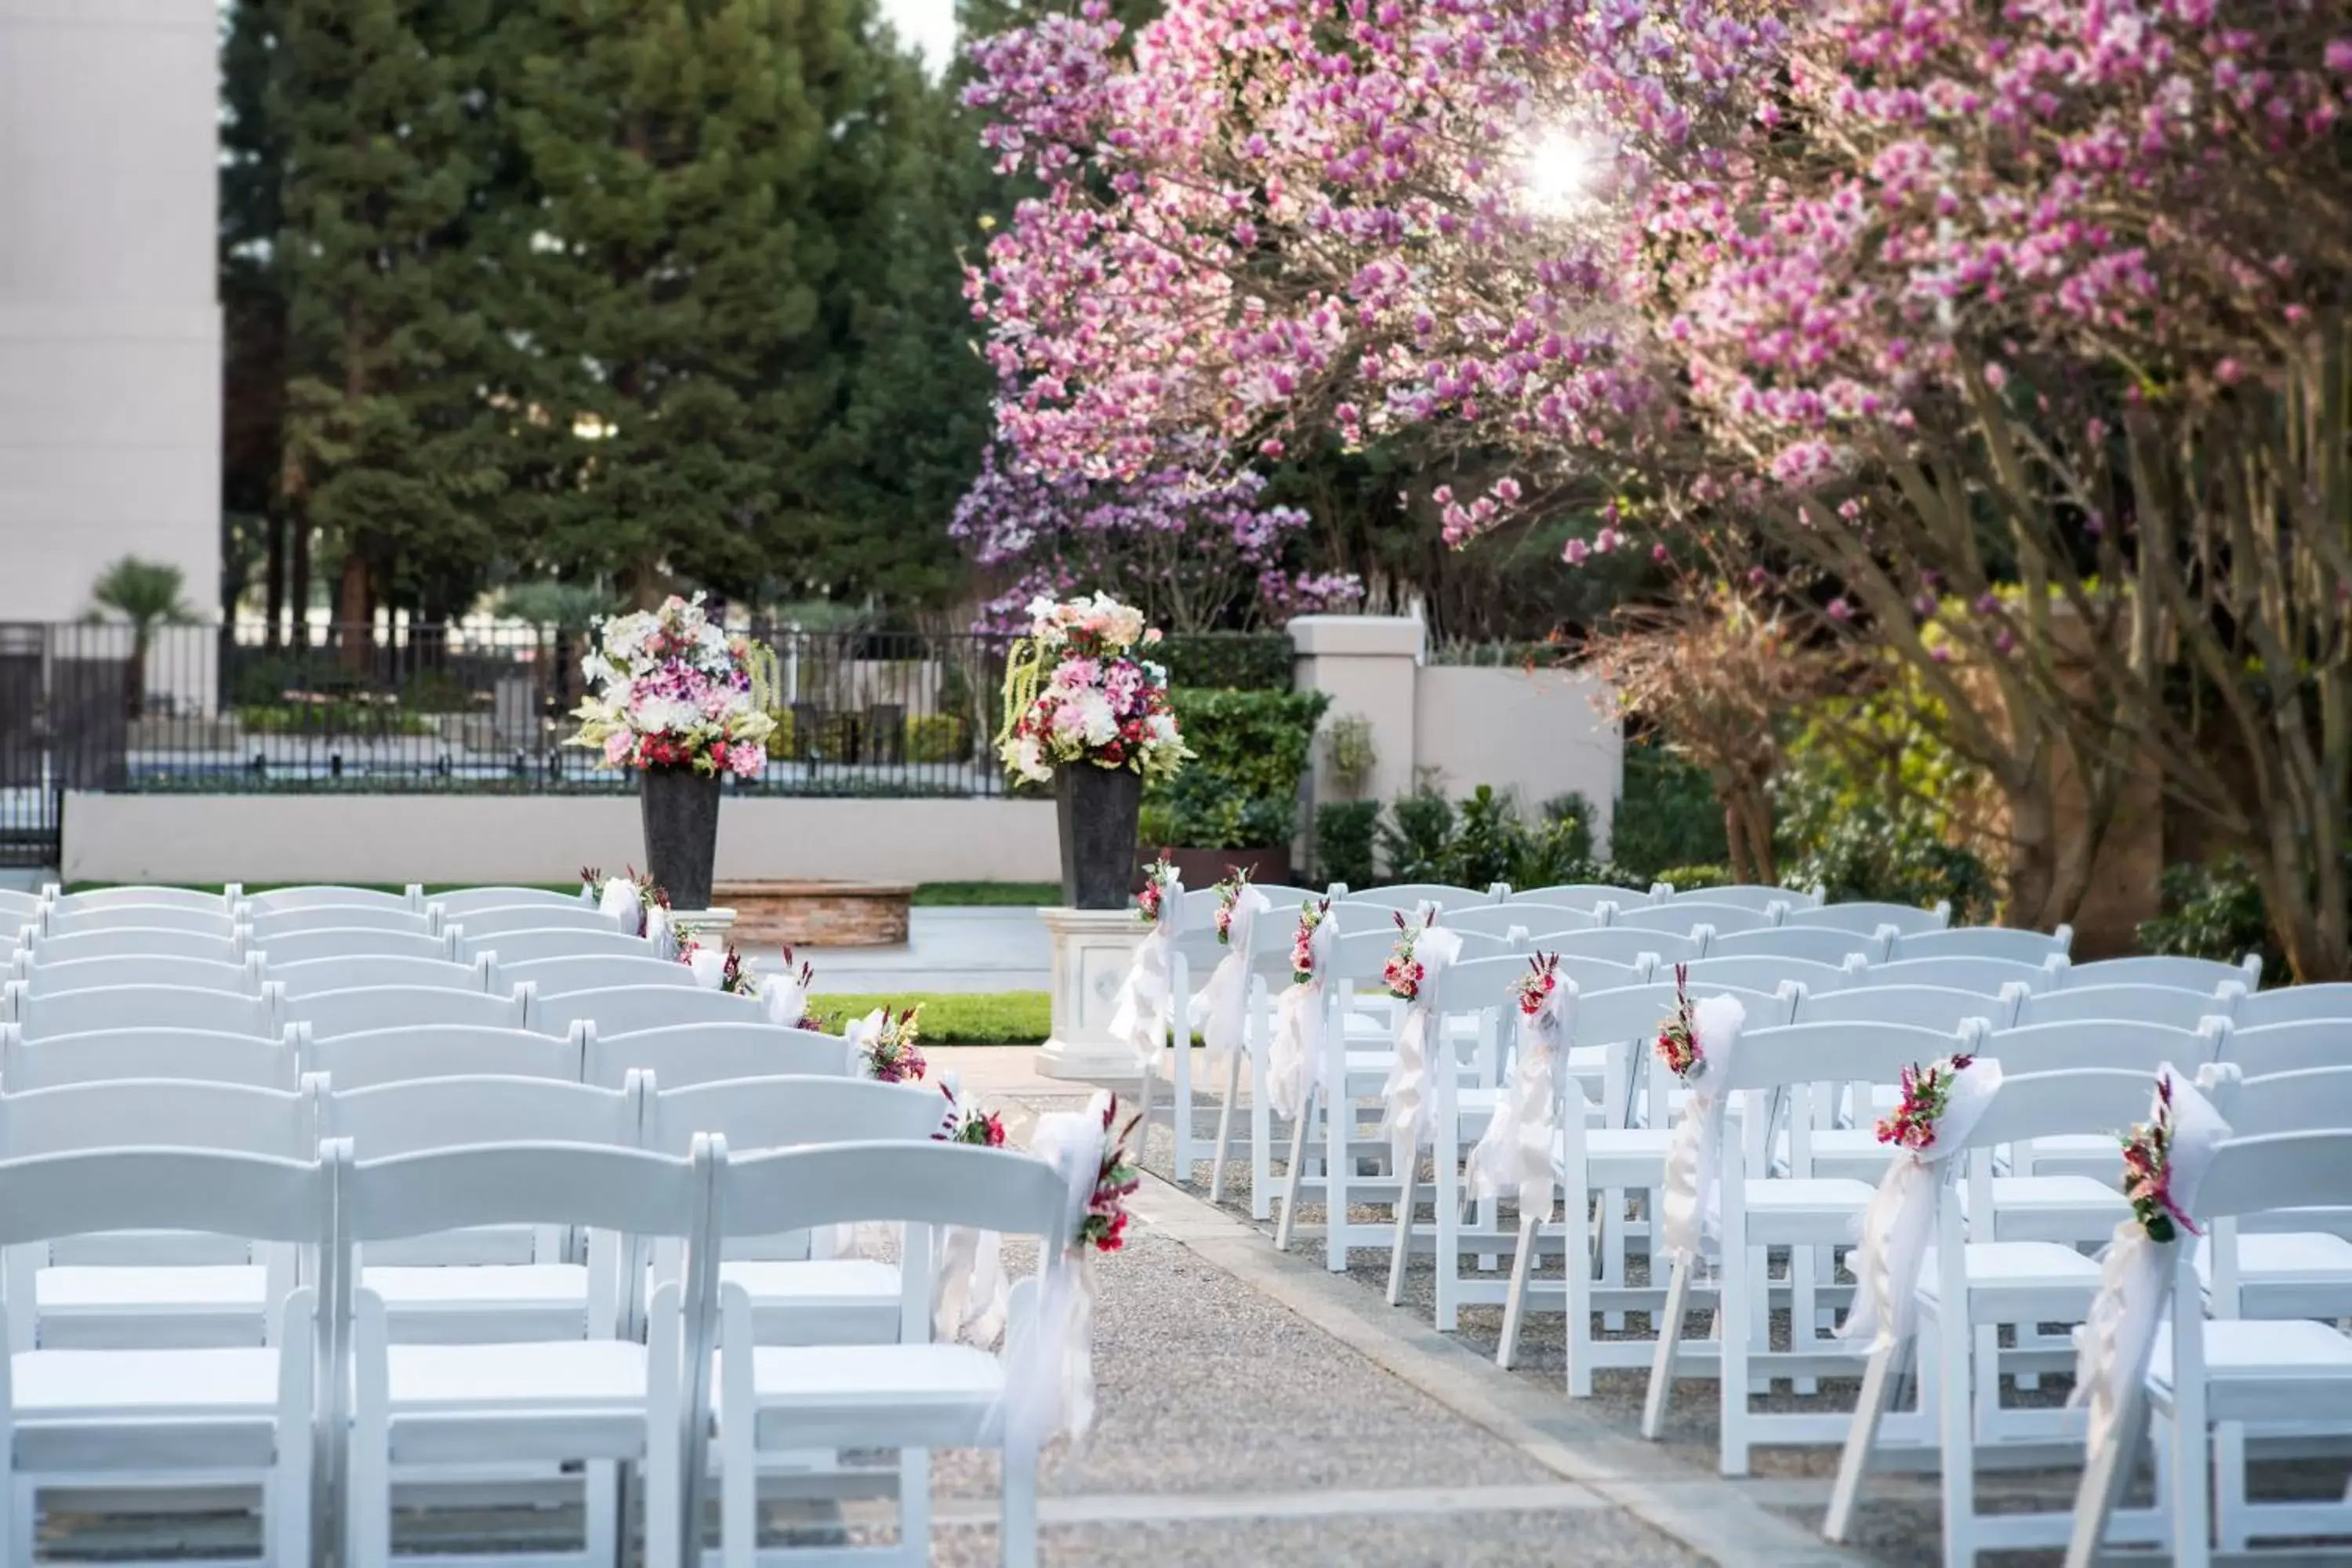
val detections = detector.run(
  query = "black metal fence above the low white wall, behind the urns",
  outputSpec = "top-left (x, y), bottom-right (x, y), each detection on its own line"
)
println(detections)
top-left (0, 626), bottom-right (1030, 862)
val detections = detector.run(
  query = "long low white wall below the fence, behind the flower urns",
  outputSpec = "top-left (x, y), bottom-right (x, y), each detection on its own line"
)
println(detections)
top-left (61, 794), bottom-right (1061, 881)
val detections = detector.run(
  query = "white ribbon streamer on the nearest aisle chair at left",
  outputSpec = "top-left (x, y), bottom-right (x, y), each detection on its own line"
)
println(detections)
top-left (1004, 1095), bottom-right (1110, 1443)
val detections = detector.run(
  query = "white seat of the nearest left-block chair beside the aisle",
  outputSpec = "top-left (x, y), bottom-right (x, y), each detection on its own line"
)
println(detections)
top-left (713, 1345), bottom-right (1004, 1448)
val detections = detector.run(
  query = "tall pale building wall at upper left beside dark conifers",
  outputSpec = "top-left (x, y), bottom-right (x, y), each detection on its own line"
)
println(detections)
top-left (0, 0), bottom-right (221, 621)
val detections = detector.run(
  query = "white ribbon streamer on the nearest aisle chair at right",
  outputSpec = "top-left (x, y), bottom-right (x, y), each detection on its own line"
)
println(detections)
top-left (2067, 1062), bottom-right (2230, 1453)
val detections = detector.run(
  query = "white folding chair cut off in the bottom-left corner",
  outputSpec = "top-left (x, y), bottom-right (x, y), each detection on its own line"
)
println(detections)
top-left (0, 1149), bottom-right (334, 1568)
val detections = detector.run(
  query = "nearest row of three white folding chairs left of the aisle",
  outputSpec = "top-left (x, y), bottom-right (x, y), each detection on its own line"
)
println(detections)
top-left (0, 1114), bottom-right (1068, 1563)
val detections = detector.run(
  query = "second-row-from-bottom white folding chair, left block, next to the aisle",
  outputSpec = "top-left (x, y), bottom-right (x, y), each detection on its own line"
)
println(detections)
top-left (644, 1074), bottom-right (946, 1345)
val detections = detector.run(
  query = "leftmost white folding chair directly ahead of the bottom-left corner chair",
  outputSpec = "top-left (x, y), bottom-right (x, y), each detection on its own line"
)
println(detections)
top-left (0, 1079), bottom-right (318, 1349)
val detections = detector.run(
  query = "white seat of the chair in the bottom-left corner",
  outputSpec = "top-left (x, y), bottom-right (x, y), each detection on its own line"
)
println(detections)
top-left (9, 1347), bottom-right (278, 1425)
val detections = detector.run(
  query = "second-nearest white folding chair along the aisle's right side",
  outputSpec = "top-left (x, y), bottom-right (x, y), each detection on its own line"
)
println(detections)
top-left (1823, 1058), bottom-right (2150, 1563)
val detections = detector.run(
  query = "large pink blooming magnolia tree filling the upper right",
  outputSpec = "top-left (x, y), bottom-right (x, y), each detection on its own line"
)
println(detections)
top-left (969, 0), bottom-right (2352, 978)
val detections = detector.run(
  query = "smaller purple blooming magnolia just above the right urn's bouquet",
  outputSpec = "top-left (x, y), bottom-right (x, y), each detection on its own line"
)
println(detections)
top-left (948, 452), bottom-right (1362, 633)
